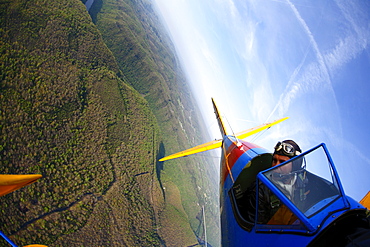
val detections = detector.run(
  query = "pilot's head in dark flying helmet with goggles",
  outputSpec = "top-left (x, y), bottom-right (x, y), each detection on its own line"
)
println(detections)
top-left (272, 140), bottom-right (302, 174)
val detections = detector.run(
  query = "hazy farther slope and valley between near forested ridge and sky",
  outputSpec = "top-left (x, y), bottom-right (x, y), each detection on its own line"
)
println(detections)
top-left (89, 0), bottom-right (219, 245)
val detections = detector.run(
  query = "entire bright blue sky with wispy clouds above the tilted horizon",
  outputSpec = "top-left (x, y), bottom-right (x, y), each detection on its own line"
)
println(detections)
top-left (153, 0), bottom-right (370, 200)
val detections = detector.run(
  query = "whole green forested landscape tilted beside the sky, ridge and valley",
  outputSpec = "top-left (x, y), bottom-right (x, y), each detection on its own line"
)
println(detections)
top-left (0, 0), bottom-right (218, 246)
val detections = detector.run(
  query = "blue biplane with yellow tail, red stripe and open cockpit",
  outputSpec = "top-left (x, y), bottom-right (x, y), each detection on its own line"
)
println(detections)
top-left (159, 99), bottom-right (370, 247)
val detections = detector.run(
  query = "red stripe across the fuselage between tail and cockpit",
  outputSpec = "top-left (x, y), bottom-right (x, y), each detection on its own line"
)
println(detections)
top-left (222, 140), bottom-right (259, 183)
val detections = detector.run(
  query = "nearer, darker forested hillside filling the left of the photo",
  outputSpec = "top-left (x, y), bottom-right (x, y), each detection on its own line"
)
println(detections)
top-left (0, 0), bottom-right (163, 246)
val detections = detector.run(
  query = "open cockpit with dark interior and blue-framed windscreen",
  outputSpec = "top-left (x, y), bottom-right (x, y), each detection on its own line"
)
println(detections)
top-left (229, 144), bottom-right (349, 234)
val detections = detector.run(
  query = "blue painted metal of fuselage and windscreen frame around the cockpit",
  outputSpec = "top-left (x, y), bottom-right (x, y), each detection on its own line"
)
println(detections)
top-left (220, 142), bottom-right (365, 246)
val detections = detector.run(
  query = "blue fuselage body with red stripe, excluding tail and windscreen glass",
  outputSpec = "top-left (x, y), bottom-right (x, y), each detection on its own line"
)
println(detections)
top-left (220, 136), bottom-right (365, 247)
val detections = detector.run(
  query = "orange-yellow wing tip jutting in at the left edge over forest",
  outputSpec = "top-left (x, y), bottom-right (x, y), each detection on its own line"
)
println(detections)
top-left (0, 174), bottom-right (42, 196)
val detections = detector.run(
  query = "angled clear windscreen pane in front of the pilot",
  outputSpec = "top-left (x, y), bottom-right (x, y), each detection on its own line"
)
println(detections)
top-left (264, 147), bottom-right (341, 218)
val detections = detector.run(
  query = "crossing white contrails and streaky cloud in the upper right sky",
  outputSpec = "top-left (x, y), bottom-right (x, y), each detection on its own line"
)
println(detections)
top-left (270, 0), bottom-right (370, 120)
